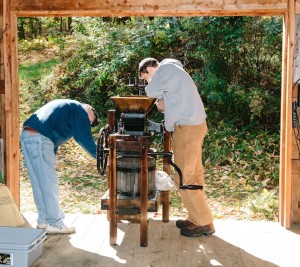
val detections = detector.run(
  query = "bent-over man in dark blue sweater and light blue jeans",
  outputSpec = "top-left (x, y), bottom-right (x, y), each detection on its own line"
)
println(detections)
top-left (21, 99), bottom-right (99, 234)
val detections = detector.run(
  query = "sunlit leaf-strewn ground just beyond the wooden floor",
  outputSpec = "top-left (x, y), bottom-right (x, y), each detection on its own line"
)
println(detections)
top-left (20, 140), bottom-right (278, 221)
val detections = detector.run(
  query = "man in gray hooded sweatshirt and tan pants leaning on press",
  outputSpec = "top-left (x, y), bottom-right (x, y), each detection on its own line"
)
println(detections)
top-left (139, 58), bottom-right (215, 237)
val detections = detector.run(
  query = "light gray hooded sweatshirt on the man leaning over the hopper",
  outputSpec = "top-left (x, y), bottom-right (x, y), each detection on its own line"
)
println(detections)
top-left (146, 59), bottom-right (206, 132)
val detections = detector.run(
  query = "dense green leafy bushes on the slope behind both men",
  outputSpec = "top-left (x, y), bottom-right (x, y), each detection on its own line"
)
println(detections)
top-left (53, 17), bottom-right (282, 132)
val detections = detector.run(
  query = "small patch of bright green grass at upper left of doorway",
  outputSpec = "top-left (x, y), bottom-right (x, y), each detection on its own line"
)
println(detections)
top-left (19, 58), bottom-right (60, 80)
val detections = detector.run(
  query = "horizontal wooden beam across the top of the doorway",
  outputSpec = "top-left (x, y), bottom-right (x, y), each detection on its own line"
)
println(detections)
top-left (11, 0), bottom-right (287, 16)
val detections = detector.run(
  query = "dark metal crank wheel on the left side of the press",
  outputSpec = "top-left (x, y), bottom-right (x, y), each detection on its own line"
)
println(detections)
top-left (97, 124), bottom-right (109, 175)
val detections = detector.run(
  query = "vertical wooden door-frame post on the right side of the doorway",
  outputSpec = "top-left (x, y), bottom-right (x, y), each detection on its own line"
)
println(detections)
top-left (279, 0), bottom-right (295, 228)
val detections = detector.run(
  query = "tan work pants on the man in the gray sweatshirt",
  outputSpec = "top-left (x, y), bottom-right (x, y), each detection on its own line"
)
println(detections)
top-left (172, 122), bottom-right (213, 226)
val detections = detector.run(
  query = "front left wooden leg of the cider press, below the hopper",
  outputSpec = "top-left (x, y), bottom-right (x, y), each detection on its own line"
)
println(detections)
top-left (109, 135), bottom-right (117, 245)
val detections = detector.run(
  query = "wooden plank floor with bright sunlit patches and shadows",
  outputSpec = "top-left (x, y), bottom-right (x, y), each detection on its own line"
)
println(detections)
top-left (23, 213), bottom-right (300, 267)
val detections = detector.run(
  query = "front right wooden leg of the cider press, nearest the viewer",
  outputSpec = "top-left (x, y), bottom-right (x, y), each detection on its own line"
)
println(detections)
top-left (140, 136), bottom-right (148, 247)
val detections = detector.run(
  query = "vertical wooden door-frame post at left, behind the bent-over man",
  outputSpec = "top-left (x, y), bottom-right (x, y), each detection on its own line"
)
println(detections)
top-left (3, 0), bottom-right (20, 206)
